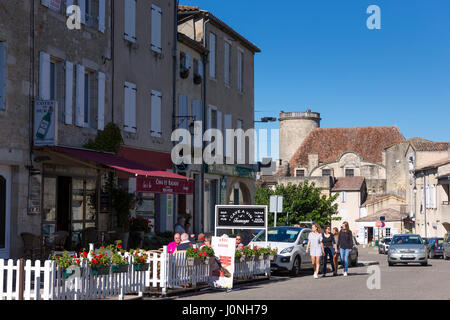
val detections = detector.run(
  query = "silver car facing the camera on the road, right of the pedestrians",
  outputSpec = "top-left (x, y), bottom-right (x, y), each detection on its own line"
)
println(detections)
top-left (388, 234), bottom-right (428, 266)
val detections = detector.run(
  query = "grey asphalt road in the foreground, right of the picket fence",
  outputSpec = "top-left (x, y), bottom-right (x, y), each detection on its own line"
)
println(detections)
top-left (171, 248), bottom-right (450, 300)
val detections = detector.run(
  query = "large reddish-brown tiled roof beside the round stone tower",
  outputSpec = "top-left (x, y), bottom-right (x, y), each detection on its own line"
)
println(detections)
top-left (289, 127), bottom-right (405, 174)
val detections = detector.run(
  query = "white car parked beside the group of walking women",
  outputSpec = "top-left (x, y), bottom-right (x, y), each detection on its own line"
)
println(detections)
top-left (249, 227), bottom-right (359, 275)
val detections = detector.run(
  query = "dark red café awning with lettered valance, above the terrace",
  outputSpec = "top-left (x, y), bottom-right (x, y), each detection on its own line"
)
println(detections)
top-left (53, 147), bottom-right (194, 194)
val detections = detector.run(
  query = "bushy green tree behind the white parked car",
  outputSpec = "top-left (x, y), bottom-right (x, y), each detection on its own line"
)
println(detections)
top-left (255, 181), bottom-right (341, 226)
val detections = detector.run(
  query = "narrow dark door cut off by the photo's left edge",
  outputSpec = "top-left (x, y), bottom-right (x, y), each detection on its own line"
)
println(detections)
top-left (0, 166), bottom-right (11, 259)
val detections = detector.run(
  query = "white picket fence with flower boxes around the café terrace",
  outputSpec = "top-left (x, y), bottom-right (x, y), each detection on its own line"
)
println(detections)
top-left (0, 246), bottom-right (270, 300)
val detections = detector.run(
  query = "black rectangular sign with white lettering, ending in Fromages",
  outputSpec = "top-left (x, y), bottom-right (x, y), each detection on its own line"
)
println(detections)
top-left (216, 206), bottom-right (267, 229)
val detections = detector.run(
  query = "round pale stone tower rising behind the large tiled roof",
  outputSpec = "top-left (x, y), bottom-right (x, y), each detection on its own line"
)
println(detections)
top-left (280, 110), bottom-right (322, 163)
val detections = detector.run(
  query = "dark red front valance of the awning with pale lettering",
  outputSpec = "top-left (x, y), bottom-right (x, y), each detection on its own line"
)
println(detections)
top-left (136, 176), bottom-right (194, 194)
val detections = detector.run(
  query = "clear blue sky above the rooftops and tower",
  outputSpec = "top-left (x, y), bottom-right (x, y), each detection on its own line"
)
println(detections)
top-left (180, 0), bottom-right (450, 160)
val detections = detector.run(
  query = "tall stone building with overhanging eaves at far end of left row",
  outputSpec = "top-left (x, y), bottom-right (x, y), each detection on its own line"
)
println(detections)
top-left (178, 6), bottom-right (261, 233)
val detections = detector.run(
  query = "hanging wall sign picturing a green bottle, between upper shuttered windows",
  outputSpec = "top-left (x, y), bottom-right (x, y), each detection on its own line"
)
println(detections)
top-left (33, 100), bottom-right (58, 146)
